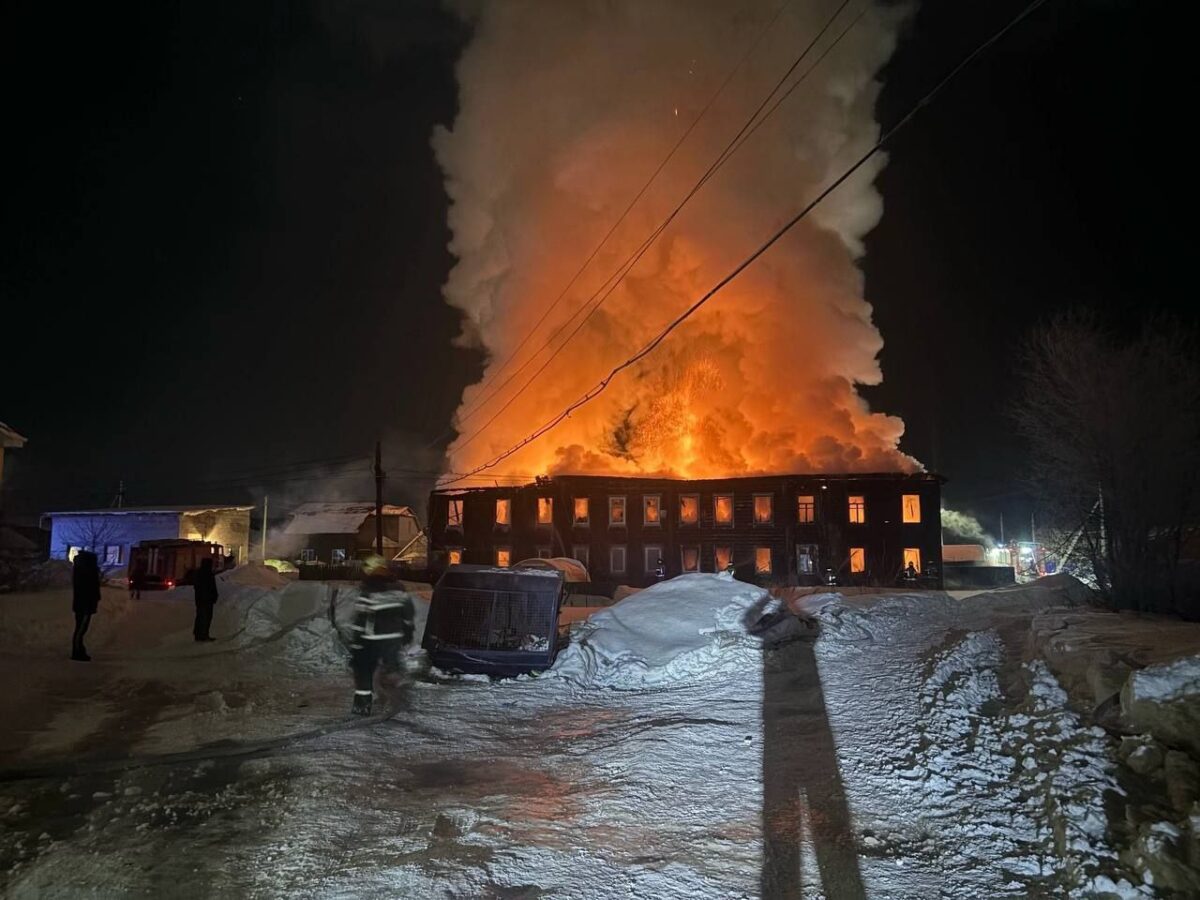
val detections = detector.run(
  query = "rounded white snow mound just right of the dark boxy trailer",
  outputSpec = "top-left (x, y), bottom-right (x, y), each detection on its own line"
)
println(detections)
top-left (547, 572), bottom-right (778, 689)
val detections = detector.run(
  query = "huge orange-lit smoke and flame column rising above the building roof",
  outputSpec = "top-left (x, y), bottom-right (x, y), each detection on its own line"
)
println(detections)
top-left (433, 0), bottom-right (918, 476)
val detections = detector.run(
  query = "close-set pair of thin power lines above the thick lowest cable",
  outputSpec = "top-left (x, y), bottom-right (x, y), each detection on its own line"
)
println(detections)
top-left (446, 0), bottom-right (865, 449)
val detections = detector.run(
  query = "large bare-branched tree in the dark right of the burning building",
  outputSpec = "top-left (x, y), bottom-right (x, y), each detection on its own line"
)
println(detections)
top-left (1015, 312), bottom-right (1200, 611)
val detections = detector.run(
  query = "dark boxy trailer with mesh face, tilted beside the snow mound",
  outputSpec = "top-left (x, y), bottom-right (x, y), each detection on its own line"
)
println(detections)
top-left (421, 565), bottom-right (564, 676)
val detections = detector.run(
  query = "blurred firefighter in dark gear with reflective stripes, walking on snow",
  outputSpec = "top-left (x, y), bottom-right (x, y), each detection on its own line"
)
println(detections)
top-left (349, 556), bottom-right (413, 715)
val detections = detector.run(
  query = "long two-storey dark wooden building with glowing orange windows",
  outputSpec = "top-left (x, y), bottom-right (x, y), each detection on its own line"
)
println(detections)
top-left (428, 473), bottom-right (942, 588)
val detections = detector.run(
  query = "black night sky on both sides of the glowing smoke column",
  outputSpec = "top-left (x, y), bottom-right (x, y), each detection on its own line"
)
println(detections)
top-left (0, 0), bottom-right (1180, 528)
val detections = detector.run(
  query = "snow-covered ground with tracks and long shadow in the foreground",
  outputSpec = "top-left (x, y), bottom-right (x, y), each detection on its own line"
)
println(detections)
top-left (0, 570), bottom-right (1194, 898)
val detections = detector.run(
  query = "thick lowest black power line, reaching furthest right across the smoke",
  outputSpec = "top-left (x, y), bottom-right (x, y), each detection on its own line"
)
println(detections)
top-left (438, 0), bottom-right (1045, 487)
